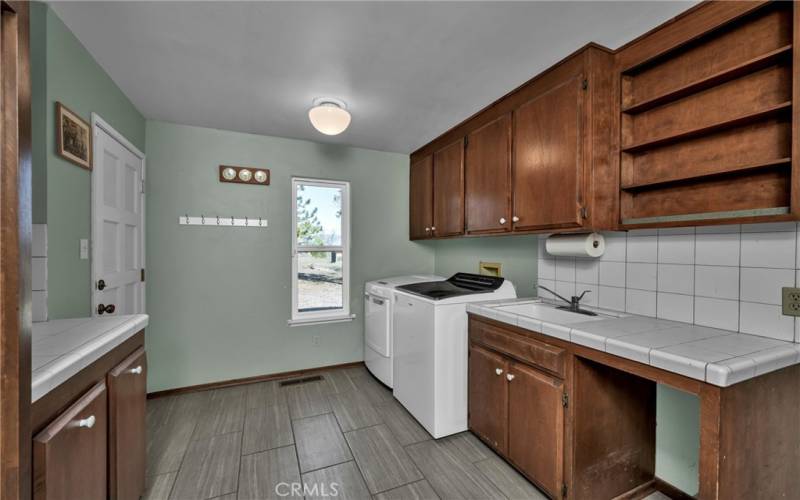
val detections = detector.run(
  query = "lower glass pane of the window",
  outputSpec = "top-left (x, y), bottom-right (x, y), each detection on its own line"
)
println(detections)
top-left (297, 252), bottom-right (343, 312)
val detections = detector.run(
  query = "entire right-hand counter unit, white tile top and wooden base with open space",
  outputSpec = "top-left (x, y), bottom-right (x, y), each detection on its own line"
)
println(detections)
top-left (468, 299), bottom-right (800, 500)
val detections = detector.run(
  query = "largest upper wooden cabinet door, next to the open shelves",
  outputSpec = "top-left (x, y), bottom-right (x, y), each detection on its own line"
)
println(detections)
top-left (513, 76), bottom-right (585, 230)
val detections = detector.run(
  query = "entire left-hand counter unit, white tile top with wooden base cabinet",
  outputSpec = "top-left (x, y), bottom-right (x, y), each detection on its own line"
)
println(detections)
top-left (31, 314), bottom-right (148, 500)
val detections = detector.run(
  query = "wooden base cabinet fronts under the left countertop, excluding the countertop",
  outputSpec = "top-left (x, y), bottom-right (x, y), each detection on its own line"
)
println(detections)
top-left (31, 331), bottom-right (147, 500)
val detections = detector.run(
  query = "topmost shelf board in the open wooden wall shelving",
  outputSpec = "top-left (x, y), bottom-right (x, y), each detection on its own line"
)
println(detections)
top-left (622, 44), bottom-right (792, 114)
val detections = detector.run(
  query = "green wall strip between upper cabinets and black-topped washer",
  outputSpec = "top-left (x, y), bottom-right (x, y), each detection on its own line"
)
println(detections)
top-left (430, 235), bottom-right (538, 297)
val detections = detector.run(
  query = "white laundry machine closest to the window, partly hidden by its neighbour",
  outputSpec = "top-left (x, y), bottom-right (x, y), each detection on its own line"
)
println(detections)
top-left (364, 274), bottom-right (444, 387)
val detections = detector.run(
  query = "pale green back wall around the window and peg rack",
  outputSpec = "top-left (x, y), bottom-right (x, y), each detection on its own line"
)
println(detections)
top-left (146, 121), bottom-right (434, 391)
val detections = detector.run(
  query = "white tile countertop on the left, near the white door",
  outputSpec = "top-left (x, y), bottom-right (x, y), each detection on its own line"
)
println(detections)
top-left (31, 314), bottom-right (150, 402)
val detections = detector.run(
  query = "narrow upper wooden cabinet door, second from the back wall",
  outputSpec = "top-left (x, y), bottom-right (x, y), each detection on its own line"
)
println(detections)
top-left (433, 139), bottom-right (464, 236)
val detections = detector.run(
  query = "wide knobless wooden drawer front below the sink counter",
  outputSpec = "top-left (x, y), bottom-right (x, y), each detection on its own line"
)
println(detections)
top-left (469, 321), bottom-right (566, 377)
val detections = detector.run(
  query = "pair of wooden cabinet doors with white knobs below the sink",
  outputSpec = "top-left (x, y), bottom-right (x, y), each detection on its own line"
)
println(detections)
top-left (468, 338), bottom-right (566, 498)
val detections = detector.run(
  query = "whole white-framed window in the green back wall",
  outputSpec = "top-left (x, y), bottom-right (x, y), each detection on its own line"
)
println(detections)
top-left (289, 178), bottom-right (352, 324)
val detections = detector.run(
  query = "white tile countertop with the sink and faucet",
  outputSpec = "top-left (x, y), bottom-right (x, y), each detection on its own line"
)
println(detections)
top-left (467, 299), bottom-right (800, 387)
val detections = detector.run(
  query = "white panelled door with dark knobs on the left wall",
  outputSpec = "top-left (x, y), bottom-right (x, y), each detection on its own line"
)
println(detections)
top-left (92, 115), bottom-right (145, 316)
